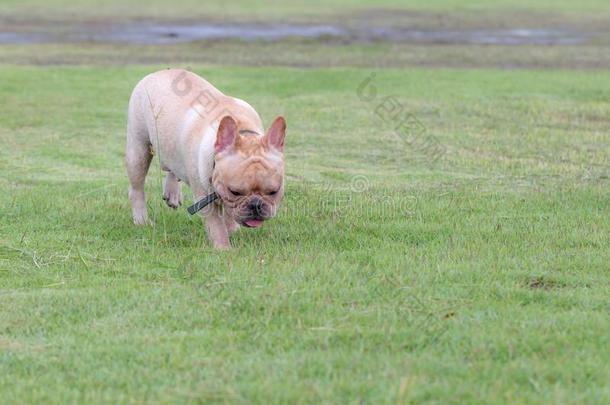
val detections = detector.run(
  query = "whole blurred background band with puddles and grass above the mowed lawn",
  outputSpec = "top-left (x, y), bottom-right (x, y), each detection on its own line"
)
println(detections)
top-left (0, 0), bottom-right (610, 69)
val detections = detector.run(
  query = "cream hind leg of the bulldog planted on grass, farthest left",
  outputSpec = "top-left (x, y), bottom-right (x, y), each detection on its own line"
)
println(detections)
top-left (125, 123), bottom-right (152, 225)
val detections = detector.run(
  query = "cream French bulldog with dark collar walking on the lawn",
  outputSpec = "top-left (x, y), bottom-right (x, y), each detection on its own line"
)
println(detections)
top-left (126, 69), bottom-right (286, 249)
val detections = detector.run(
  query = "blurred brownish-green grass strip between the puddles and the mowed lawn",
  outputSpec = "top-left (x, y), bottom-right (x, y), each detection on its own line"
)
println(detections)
top-left (0, 40), bottom-right (610, 70)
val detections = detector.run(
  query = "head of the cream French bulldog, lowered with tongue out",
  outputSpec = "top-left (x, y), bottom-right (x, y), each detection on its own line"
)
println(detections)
top-left (212, 116), bottom-right (286, 228)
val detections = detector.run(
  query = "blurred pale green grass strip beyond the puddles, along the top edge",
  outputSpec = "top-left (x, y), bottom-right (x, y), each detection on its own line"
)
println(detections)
top-left (0, 0), bottom-right (610, 20)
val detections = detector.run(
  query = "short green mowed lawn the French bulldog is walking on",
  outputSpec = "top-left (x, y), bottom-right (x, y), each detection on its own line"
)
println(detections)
top-left (0, 66), bottom-right (610, 404)
